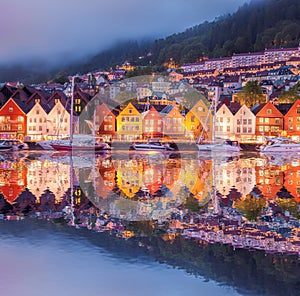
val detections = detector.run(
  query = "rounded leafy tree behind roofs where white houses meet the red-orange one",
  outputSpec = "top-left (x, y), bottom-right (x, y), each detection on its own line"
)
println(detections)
top-left (237, 81), bottom-right (266, 107)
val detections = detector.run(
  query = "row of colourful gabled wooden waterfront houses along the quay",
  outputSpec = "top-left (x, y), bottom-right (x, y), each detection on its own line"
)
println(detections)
top-left (0, 80), bottom-right (300, 142)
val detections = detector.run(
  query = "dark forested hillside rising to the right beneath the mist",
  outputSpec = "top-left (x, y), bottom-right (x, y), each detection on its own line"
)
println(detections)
top-left (0, 0), bottom-right (300, 82)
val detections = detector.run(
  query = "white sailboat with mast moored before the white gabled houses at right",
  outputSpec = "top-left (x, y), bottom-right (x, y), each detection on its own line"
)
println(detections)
top-left (197, 100), bottom-right (242, 153)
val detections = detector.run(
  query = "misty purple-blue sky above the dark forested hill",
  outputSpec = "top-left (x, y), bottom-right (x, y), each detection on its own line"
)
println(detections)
top-left (0, 0), bottom-right (249, 64)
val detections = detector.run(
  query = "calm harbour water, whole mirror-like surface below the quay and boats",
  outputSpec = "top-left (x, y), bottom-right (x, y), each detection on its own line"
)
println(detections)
top-left (0, 151), bottom-right (300, 295)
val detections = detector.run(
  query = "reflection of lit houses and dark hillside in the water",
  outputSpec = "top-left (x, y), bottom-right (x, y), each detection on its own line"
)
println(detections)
top-left (0, 152), bottom-right (300, 294)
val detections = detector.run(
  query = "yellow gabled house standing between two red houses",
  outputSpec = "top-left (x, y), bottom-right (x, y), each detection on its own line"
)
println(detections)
top-left (117, 103), bottom-right (143, 141)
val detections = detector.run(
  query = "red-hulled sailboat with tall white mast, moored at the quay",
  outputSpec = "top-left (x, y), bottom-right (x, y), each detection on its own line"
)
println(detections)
top-left (51, 76), bottom-right (110, 152)
